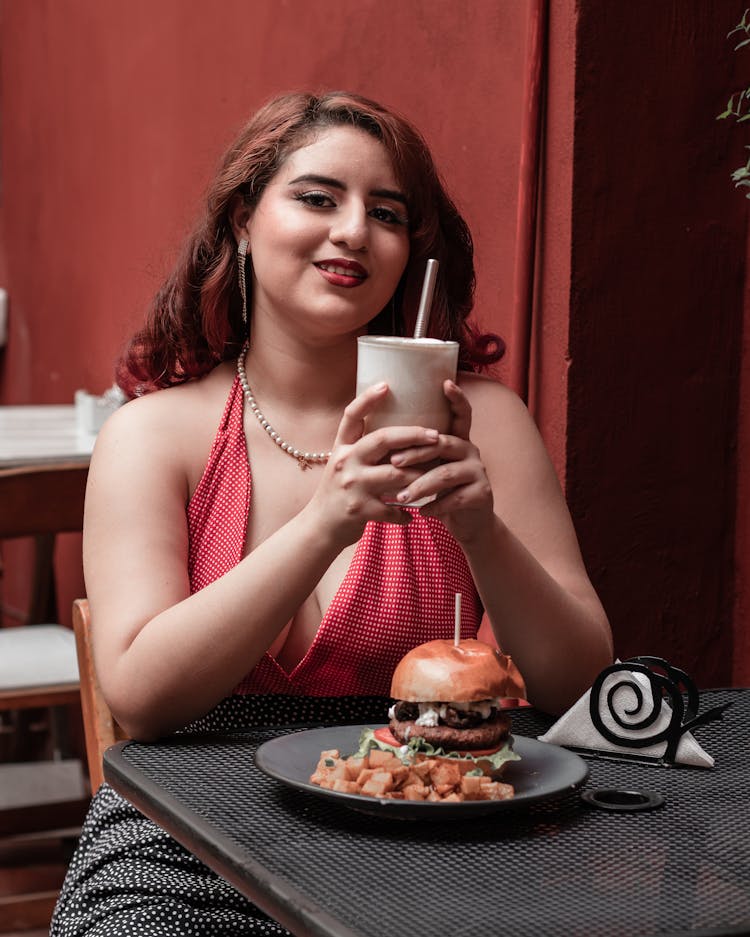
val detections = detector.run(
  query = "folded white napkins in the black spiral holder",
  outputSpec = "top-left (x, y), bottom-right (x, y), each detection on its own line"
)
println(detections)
top-left (538, 670), bottom-right (714, 768)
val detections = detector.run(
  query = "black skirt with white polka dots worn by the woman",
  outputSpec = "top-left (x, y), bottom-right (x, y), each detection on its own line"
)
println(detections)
top-left (50, 696), bottom-right (389, 937)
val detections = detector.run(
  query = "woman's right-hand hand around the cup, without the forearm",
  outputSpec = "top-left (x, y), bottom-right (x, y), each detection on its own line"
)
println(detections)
top-left (384, 381), bottom-right (494, 543)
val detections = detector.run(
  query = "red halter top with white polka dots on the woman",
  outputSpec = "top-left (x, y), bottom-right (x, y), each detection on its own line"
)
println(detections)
top-left (187, 378), bottom-right (482, 696)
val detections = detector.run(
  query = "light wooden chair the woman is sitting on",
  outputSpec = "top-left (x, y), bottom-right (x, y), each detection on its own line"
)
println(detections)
top-left (73, 599), bottom-right (127, 794)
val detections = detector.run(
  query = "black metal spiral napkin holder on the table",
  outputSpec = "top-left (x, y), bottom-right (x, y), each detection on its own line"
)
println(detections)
top-left (587, 656), bottom-right (731, 767)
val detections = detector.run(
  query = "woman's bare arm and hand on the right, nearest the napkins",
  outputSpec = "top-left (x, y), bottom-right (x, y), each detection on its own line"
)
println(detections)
top-left (393, 375), bottom-right (612, 712)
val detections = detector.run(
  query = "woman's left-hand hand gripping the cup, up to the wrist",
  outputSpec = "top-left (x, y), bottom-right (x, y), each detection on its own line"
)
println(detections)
top-left (309, 383), bottom-right (444, 543)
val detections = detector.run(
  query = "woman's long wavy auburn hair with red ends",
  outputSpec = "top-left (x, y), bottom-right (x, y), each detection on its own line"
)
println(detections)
top-left (116, 91), bottom-right (505, 397)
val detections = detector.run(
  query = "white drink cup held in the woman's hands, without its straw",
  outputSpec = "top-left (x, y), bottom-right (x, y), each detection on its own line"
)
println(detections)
top-left (357, 335), bottom-right (458, 433)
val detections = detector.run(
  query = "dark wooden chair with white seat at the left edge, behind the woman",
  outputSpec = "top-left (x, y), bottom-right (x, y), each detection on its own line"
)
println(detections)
top-left (0, 464), bottom-right (89, 933)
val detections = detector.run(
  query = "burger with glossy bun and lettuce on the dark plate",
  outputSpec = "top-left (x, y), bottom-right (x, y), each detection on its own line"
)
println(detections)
top-left (362, 639), bottom-right (518, 776)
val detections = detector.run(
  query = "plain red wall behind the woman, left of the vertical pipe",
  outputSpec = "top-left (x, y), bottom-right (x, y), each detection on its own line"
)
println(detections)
top-left (1, 0), bottom-right (526, 403)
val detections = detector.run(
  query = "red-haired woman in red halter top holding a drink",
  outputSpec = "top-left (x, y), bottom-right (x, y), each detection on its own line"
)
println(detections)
top-left (52, 93), bottom-right (612, 935)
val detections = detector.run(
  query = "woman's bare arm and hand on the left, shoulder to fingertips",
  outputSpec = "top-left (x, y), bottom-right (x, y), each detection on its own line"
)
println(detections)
top-left (84, 378), bottom-right (437, 739)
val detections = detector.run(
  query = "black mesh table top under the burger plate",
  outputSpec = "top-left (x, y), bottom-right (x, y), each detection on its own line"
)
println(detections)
top-left (105, 689), bottom-right (750, 937)
